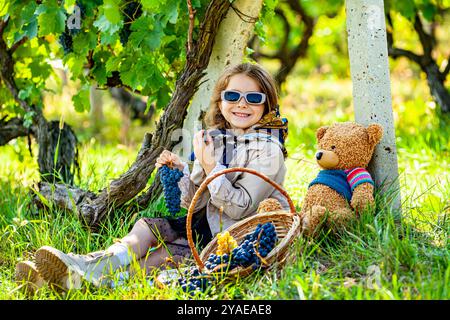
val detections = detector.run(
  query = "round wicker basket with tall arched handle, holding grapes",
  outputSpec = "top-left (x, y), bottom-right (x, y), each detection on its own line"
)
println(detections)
top-left (186, 167), bottom-right (301, 278)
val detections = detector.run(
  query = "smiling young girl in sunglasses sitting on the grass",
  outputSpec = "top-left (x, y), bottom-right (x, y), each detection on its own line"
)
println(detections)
top-left (16, 64), bottom-right (289, 289)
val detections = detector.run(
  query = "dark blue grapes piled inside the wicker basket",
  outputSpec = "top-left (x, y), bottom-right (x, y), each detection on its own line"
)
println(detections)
top-left (205, 222), bottom-right (277, 271)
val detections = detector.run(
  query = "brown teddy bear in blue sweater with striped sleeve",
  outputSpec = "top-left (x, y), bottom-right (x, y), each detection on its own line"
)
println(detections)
top-left (300, 122), bottom-right (383, 236)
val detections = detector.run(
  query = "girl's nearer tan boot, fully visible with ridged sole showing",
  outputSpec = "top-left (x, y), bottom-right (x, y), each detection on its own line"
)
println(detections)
top-left (35, 246), bottom-right (121, 290)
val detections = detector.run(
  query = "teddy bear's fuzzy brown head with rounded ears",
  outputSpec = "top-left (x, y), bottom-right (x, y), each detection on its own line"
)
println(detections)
top-left (316, 122), bottom-right (383, 170)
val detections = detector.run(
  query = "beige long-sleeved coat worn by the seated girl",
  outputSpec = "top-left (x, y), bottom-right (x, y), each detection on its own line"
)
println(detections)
top-left (179, 126), bottom-right (289, 236)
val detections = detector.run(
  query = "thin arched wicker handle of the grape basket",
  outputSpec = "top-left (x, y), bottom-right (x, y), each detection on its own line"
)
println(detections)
top-left (186, 167), bottom-right (296, 271)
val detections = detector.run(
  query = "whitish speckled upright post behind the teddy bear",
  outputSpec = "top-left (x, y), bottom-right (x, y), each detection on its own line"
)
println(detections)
top-left (346, 0), bottom-right (401, 220)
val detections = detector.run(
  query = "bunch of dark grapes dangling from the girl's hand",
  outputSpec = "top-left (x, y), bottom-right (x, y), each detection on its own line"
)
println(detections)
top-left (159, 165), bottom-right (183, 215)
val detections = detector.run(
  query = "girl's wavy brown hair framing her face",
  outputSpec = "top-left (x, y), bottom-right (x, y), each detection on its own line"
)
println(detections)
top-left (205, 63), bottom-right (278, 129)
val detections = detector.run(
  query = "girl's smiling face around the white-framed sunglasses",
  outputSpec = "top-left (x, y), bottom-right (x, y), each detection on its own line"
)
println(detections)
top-left (219, 73), bottom-right (264, 130)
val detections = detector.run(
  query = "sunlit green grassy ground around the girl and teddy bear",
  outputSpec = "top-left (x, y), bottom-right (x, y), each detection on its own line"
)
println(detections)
top-left (0, 70), bottom-right (450, 299)
